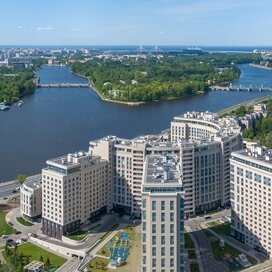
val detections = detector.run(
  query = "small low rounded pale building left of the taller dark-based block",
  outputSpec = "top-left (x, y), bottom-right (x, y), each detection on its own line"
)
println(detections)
top-left (20, 175), bottom-right (42, 221)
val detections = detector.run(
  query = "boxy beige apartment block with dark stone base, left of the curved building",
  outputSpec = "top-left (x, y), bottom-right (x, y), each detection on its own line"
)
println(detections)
top-left (42, 151), bottom-right (108, 239)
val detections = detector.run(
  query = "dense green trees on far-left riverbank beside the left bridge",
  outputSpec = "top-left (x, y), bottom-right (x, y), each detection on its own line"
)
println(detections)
top-left (0, 68), bottom-right (35, 103)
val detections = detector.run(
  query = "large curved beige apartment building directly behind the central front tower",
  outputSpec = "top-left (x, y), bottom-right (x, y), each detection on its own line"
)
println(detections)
top-left (89, 112), bottom-right (242, 217)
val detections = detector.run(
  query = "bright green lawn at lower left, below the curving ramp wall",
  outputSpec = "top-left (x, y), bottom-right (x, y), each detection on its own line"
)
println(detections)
top-left (18, 243), bottom-right (66, 267)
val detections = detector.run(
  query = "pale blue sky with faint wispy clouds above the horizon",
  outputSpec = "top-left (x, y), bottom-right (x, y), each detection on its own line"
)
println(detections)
top-left (0, 0), bottom-right (272, 46)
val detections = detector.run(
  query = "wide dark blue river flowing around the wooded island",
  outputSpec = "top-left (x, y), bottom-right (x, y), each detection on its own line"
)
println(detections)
top-left (0, 65), bottom-right (272, 181)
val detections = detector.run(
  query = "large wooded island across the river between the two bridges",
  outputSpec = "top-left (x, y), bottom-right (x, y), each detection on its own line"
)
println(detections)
top-left (71, 54), bottom-right (259, 102)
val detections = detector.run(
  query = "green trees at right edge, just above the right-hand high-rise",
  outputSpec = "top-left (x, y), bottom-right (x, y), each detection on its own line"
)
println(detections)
top-left (243, 101), bottom-right (272, 148)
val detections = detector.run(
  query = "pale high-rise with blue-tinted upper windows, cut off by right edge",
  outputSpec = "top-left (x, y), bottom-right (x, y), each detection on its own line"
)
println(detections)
top-left (230, 145), bottom-right (272, 257)
